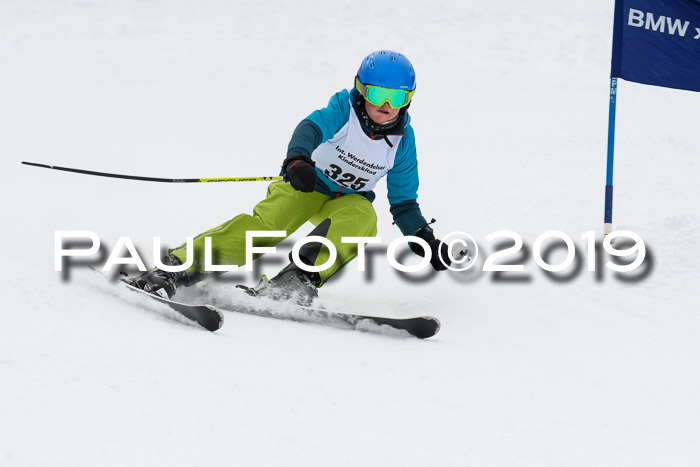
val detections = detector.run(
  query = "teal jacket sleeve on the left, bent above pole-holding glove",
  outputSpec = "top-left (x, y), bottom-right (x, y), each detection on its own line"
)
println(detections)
top-left (287, 91), bottom-right (350, 157)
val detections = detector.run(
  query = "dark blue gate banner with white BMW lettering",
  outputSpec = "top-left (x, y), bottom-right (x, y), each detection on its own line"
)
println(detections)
top-left (610, 0), bottom-right (700, 91)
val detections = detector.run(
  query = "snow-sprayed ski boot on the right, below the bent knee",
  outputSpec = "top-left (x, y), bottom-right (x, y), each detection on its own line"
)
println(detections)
top-left (236, 263), bottom-right (321, 306)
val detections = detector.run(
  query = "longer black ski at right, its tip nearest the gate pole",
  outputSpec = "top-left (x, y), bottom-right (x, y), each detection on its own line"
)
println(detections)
top-left (222, 303), bottom-right (440, 339)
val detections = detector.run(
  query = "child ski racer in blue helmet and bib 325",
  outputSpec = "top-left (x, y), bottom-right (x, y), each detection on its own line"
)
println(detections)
top-left (127, 50), bottom-right (450, 304)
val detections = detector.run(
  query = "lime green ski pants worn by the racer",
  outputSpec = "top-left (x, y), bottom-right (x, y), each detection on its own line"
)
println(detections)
top-left (170, 182), bottom-right (377, 284)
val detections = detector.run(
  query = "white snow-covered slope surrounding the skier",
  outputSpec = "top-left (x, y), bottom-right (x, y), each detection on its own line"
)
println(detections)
top-left (0, 0), bottom-right (700, 467)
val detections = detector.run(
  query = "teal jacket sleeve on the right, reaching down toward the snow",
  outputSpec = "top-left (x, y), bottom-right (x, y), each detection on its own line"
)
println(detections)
top-left (386, 126), bottom-right (430, 235)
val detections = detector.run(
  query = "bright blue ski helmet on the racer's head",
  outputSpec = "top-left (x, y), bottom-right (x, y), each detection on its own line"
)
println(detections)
top-left (357, 50), bottom-right (416, 91)
